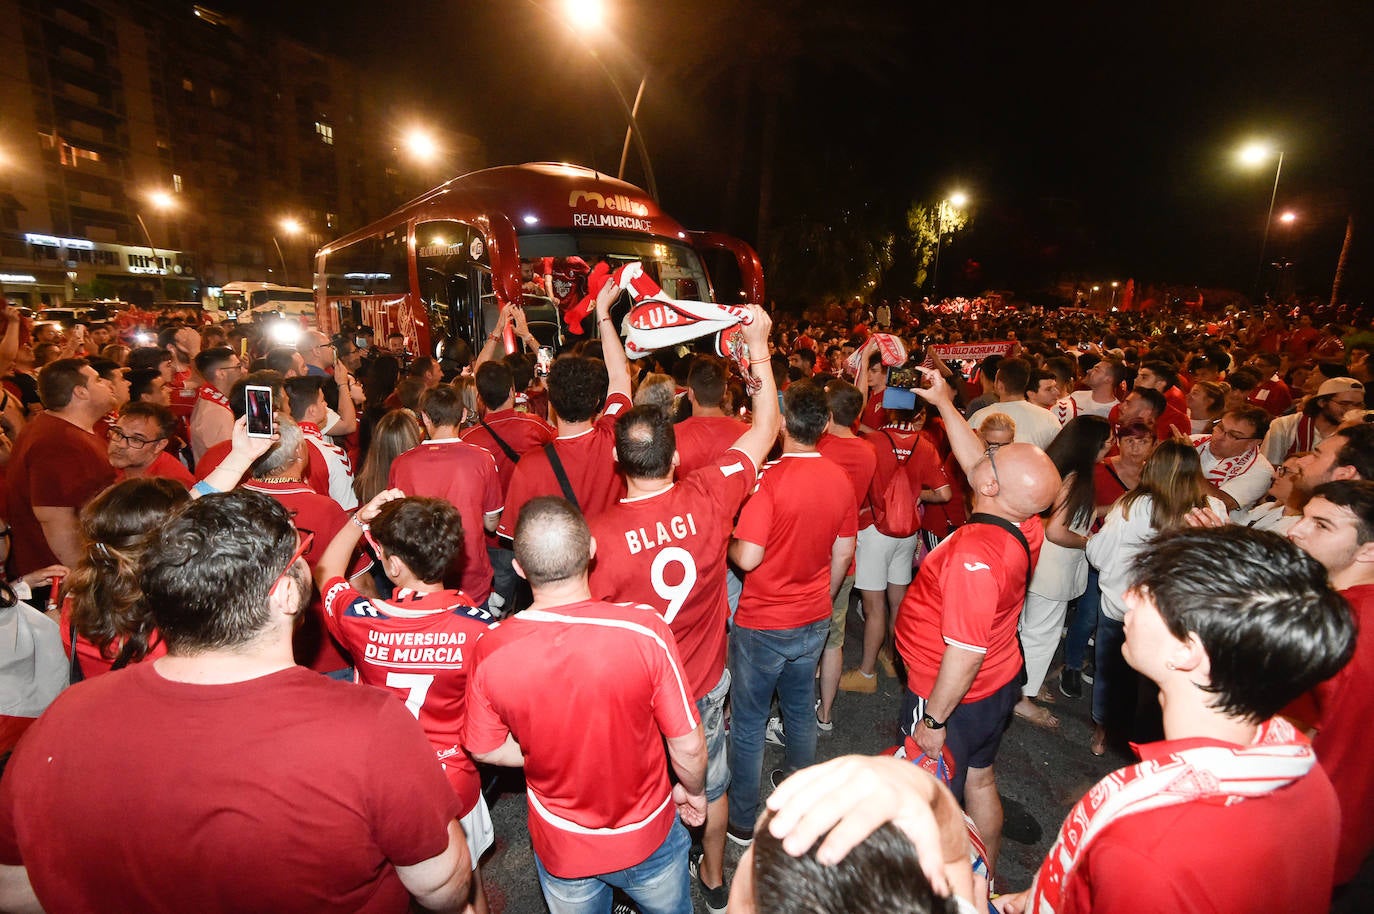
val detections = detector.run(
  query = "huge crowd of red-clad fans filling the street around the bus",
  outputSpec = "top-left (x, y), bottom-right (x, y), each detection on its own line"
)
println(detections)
top-left (0, 283), bottom-right (1374, 914)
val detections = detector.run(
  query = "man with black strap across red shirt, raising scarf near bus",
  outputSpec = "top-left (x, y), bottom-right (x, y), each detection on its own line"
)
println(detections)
top-left (499, 280), bottom-right (632, 537)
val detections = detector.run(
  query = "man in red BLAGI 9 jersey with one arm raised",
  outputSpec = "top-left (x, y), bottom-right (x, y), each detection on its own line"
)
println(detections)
top-left (589, 306), bottom-right (778, 914)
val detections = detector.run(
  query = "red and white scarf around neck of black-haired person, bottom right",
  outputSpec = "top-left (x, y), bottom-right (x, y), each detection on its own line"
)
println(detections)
top-left (1026, 717), bottom-right (1316, 914)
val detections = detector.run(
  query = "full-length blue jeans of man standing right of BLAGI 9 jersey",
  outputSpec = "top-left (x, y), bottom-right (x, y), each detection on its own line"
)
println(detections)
top-left (730, 617), bottom-right (830, 829)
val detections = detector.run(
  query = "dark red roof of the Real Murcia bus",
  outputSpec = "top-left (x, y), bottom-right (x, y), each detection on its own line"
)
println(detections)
top-left (322, 162), bottom-right (691, 253)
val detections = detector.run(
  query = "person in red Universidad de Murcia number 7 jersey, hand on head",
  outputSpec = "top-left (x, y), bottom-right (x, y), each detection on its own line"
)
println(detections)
top-left (315, 489), bottom-right (493, 914)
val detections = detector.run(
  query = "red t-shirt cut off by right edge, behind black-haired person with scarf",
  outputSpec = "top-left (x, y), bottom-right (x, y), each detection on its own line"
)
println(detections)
top-left (1308, 584), bottom-right (1374, 885)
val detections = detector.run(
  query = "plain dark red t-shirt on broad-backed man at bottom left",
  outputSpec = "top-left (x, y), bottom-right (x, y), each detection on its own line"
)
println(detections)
top-left (0, 664), bottom-right (459, 914)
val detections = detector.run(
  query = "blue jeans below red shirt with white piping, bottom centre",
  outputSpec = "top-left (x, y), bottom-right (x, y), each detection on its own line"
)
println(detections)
top-left (534, 819), bottom-right (692, 914)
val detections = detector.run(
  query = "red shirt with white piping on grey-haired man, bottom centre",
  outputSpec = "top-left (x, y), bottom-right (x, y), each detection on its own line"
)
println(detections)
top-left (463, 601), bottom-right (698, 878)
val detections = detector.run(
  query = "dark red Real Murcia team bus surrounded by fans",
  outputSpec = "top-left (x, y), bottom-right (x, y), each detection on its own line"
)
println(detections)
top-left (315, 164), bottom-right (764, 368)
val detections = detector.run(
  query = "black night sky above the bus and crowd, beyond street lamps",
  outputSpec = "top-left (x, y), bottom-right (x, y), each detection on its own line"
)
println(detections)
top-left (220, 0), bottom-right (1374, 300)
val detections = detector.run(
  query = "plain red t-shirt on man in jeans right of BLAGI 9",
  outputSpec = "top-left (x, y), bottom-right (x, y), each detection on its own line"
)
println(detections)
top-left (735, 451), bottom-right (859, 629)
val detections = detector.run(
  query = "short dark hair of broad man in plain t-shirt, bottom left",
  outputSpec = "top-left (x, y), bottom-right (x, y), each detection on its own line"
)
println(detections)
top-left (140, 489), bottom-right (298, 653)
